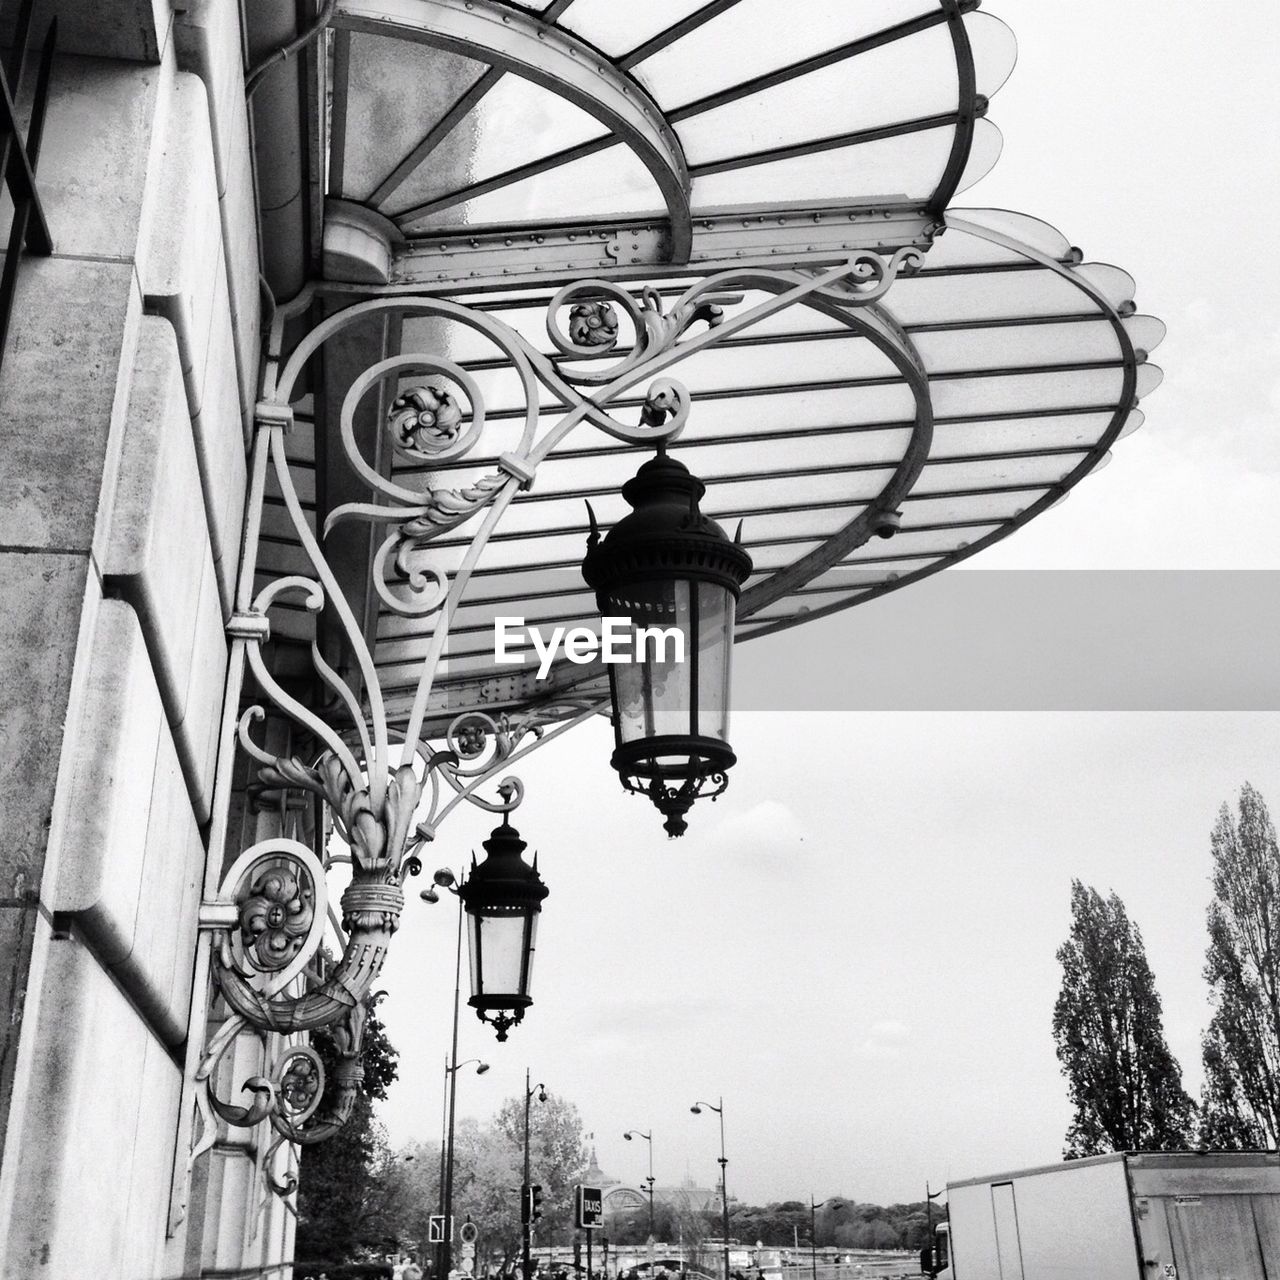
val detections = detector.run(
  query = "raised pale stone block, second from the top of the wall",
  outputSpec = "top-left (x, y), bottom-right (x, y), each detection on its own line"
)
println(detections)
top-left (101, 316), bottom-right (210, 724)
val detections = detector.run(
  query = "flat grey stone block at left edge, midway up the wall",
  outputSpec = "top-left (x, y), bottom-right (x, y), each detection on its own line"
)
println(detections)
top-left (0, 550), bottom-right (91, 890)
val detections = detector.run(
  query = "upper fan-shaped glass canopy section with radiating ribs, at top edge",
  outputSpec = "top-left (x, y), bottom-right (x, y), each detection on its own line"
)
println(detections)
top-left (329, 0), bottom-right (1015, 247)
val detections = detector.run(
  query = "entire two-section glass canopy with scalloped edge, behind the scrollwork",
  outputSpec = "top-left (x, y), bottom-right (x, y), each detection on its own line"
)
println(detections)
top-left (259, 0), bottom-right (1164, 742)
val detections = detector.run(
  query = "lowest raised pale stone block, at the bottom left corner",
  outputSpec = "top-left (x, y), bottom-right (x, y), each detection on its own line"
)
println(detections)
top-left (4, 940), bottom-right (180, 1276)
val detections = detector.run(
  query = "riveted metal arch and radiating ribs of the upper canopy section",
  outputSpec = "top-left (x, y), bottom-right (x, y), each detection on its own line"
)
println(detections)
top-left (330, 0), bottom-right (987, 288)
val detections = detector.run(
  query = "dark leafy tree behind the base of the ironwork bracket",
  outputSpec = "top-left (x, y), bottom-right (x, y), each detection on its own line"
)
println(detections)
top-left (294, 1009), bottom-right (398, 1276)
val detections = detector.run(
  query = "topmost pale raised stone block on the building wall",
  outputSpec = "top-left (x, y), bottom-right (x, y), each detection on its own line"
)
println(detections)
top-left (141, 72), bottom-right (227, 417)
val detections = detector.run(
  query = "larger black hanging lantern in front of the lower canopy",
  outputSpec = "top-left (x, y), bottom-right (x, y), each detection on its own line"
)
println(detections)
top-left (582, 445), bottom-right (751, 836)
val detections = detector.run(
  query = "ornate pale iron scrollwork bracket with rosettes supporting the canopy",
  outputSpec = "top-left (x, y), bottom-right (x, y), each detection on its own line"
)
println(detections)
top-left (192, 250), bottom-right (919, 1177)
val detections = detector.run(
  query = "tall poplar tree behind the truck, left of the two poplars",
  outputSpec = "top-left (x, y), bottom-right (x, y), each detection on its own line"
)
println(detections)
top-left (1053, 881), bottom-right (1196, 1160)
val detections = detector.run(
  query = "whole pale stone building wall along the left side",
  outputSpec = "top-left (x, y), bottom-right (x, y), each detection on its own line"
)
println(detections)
top-left (0, 0), bottom-right (282, 1280)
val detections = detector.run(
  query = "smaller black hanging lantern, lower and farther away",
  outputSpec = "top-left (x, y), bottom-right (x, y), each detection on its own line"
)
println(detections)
top-left (458, 818), bottom-right (548, 1041)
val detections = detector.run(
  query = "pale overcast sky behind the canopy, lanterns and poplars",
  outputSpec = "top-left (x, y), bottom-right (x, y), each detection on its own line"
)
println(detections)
top-left (366, 0), bottom-right (1280, 1202)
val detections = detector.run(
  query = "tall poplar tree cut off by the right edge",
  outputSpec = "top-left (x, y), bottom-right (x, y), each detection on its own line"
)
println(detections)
top-left (1201, 783), bottom-right (1280, 1149)
